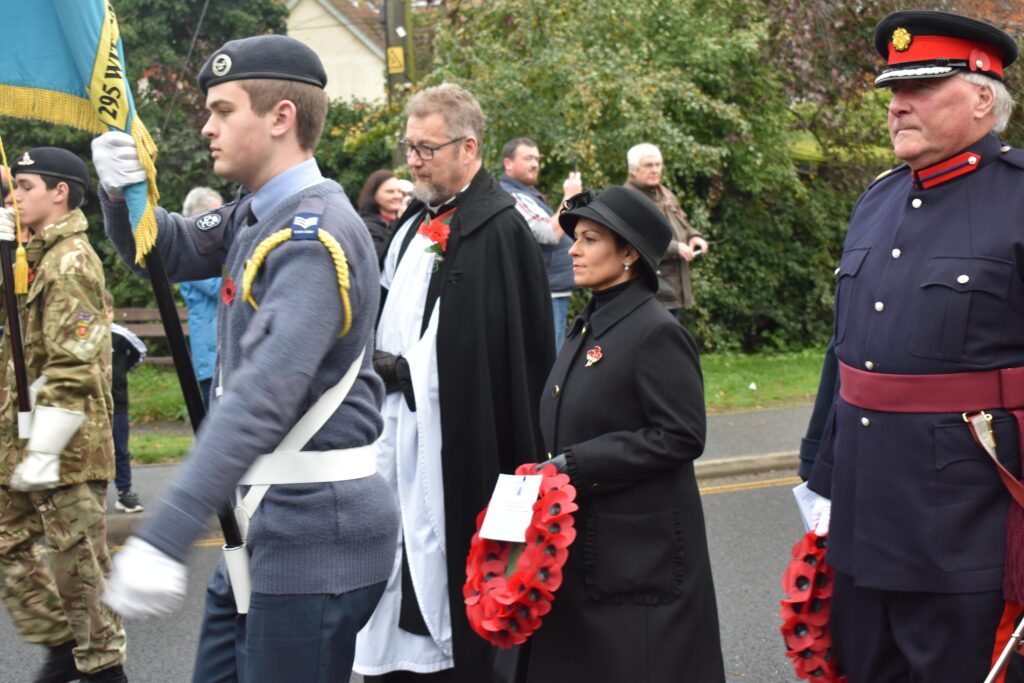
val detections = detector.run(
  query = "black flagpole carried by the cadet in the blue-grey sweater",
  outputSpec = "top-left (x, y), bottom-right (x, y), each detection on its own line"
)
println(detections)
top-left (143, 249), bottom-right (244, 549)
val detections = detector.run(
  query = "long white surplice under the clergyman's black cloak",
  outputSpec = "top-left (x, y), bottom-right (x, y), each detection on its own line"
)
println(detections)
top-left (353, 214), bottom-right (455, 676)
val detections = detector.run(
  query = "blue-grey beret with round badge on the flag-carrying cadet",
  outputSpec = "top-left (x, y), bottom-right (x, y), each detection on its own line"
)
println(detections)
top-left (199, 35), bottom-right (327, 94)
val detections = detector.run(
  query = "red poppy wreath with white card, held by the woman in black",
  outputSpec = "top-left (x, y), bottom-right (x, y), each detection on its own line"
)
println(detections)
top-left (462, 463), bottom-right (579, 648)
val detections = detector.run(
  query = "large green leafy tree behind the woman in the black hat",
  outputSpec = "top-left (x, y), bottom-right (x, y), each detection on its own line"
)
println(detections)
top-left (417, 0), bottom-right (851, 349)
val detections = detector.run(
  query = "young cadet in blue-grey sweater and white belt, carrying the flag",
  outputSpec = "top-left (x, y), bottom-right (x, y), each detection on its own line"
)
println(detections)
top-left (93, 36), bottom-right (398, 683)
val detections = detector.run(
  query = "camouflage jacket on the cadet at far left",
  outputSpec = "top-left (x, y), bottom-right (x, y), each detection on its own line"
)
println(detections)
top-left (0, 210), bottom-right (114, 485)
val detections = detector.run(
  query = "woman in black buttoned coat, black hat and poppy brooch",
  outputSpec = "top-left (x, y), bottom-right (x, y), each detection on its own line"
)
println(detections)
top-left (518, 186), bottom-right (725, 683)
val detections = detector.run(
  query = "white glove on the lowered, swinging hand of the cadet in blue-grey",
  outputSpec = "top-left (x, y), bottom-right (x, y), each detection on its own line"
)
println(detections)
top-left (103, 537), bottom-right (186, 618)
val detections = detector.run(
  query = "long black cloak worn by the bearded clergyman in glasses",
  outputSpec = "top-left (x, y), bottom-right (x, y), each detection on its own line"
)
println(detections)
top-left (385, 169), bottom-right (555, 683)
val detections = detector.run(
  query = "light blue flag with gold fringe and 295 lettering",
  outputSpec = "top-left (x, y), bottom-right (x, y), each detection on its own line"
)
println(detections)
top-left (0, 0), bottom-right (160, 263)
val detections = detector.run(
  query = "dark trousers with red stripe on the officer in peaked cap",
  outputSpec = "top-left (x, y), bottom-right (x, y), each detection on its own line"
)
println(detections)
top-left (831, 571), bottom-right (1024, 683)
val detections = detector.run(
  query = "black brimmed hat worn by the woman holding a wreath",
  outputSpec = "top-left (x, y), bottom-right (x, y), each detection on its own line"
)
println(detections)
top-left (558, 185), bottom-right (672, 292)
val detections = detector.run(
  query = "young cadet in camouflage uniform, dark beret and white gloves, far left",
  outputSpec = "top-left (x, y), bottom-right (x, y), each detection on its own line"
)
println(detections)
top-left (0, 147), bottom-right (127, 683)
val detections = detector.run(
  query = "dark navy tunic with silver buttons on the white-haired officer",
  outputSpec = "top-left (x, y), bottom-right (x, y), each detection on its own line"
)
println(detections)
top-left (810, 135), bottom-right (1024, 593)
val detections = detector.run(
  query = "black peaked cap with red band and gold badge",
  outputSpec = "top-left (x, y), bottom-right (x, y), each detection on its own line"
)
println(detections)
top-left (874, 10), bottom-right (1018, 86)
